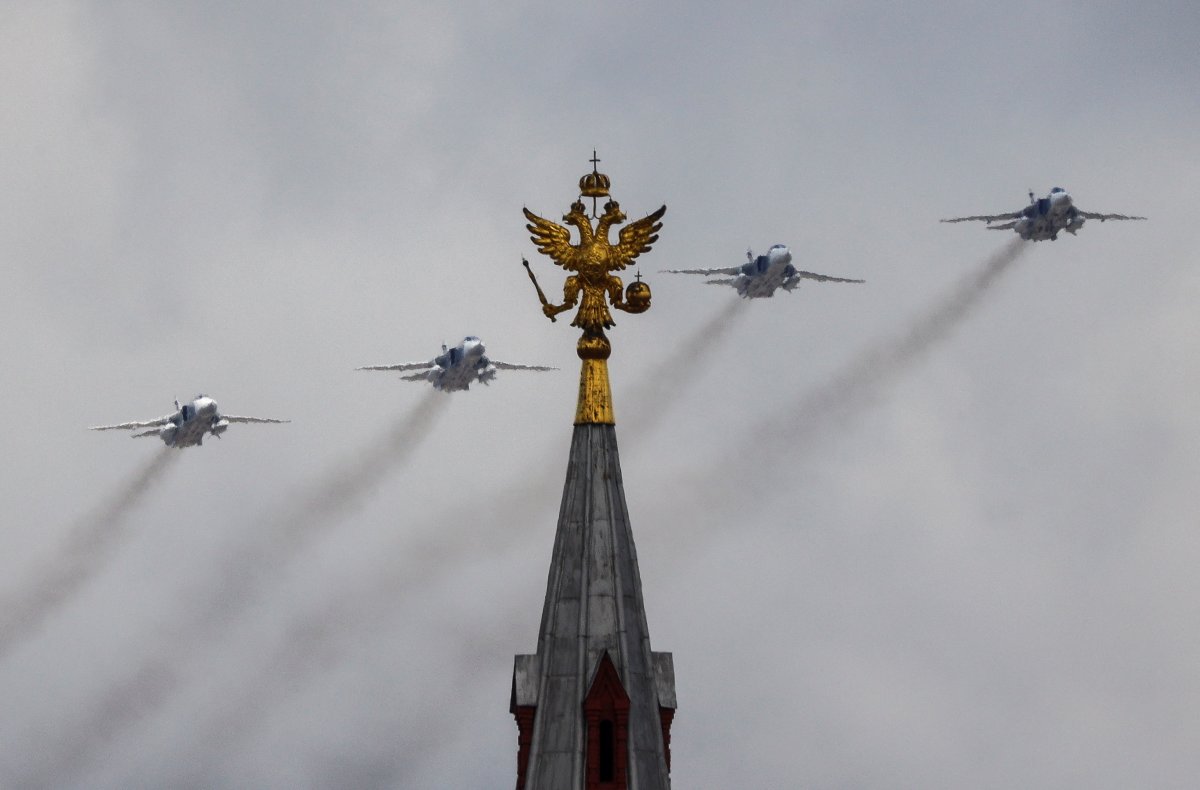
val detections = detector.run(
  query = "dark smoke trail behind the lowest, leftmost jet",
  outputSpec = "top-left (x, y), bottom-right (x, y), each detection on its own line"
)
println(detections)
top-left (0, 447), bottom-right (179, 657)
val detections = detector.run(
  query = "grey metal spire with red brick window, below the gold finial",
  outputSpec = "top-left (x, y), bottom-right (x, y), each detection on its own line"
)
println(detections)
top-left (511, 424), bottom-right (676, 790)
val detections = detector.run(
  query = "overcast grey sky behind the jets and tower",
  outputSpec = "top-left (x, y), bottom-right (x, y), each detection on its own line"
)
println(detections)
top-left (0, 0), bottom-right (1200, 790)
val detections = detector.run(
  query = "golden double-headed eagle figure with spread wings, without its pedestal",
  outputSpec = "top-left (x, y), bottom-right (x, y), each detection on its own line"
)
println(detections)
top-left (524, 201), bottom-right (667, 336)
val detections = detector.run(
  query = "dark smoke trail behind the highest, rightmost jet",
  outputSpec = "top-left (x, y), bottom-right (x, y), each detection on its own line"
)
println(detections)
top-left (746, 239), bottom-right (1030, 454)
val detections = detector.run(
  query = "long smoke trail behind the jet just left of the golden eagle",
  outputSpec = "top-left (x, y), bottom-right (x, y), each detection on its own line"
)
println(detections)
top-left (7, 390), bottom-right (450, 786)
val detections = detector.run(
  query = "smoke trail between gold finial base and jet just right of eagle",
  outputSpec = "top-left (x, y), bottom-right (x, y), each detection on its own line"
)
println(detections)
top-left (616, 298), bottom-right (746, 436)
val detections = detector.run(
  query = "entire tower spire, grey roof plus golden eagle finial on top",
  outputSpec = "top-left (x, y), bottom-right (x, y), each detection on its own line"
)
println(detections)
top-left (509, 159), bottom-right (676, 790)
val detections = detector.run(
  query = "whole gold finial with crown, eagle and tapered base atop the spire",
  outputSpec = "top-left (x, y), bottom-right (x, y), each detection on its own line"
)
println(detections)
top-left (522, 150), bottom-right (667, 425)
